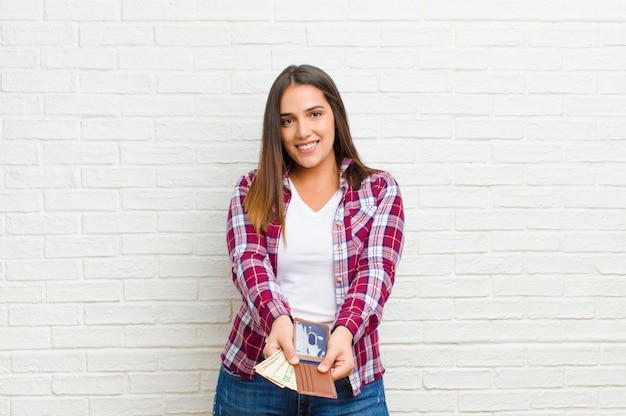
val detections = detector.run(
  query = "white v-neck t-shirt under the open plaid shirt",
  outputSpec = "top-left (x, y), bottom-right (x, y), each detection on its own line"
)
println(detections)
top-left (277, 180), bottom-right (341, 325)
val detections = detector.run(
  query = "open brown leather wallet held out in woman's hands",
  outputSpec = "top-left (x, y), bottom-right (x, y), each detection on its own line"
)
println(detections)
top-left (294, 318), bottom-right (337, 399)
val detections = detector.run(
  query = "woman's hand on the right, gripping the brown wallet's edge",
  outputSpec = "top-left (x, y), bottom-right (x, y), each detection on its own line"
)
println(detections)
top-left (317, 326), bottom-right (354, 380)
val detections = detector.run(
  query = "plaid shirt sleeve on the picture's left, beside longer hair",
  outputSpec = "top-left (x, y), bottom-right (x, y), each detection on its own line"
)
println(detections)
top-left (226, 175), bottom-right (290, 334)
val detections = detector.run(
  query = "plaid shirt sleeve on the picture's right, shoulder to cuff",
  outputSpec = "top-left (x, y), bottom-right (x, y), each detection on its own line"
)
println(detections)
top-left (335, 174), bottom-right (404, 343)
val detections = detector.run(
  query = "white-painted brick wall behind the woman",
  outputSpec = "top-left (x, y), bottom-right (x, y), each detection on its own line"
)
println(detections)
top-left (0, 0), bottom-right (626, 416)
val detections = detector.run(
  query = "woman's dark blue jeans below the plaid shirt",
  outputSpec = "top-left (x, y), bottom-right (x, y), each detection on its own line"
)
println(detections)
top-left (213, 366), bottom-right (389, 416)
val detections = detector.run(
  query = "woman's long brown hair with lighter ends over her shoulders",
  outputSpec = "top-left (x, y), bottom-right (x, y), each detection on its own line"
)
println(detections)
top-left (244, 65), bottom-right (374, 232)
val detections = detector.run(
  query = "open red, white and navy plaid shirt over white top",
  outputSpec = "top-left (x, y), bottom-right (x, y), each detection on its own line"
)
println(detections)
top-left (221, 159), bottom-right (404, 395)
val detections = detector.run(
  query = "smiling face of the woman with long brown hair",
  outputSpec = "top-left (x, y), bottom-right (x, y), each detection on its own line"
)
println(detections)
top-left (280, 84), bottom-right (336, 173)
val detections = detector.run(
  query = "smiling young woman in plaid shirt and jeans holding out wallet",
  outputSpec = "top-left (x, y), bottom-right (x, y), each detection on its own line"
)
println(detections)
top-left (214, 65), bottom-right (404, 416)
